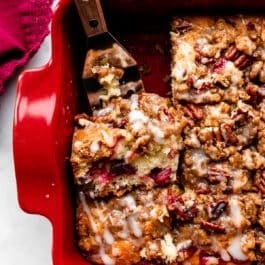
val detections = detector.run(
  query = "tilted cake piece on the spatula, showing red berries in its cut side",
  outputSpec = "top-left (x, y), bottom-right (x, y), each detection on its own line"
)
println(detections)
top-left (71, 93), bottom-right (186, 197)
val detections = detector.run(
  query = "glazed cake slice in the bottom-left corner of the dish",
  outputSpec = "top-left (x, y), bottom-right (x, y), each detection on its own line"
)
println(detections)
top-left (77, 187), bottom-right (178, 265)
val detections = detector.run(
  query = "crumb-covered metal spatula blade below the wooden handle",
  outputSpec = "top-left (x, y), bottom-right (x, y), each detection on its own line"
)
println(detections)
top-left (83, 44), bottom-right (144, 108)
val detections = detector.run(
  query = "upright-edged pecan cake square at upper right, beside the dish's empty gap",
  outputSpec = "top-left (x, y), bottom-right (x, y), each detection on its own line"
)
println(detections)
top-left (171, 16), bottom-right (265, 104)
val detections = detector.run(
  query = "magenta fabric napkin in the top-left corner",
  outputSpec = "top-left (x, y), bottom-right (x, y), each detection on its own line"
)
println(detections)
top-left (0, 0), bottom-right (52, 95)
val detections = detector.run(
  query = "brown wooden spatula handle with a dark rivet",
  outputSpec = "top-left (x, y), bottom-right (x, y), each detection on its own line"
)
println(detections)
top-left (75, 0), bottom-right (108, 37)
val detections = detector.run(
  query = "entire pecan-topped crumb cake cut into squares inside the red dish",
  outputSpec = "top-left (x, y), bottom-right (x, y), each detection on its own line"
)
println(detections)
top-left (71, 13), bottom-right (265, 265)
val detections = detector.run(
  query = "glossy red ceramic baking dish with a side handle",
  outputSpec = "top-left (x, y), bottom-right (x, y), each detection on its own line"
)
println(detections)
top-left (13, 0), bottom-right (265, 265)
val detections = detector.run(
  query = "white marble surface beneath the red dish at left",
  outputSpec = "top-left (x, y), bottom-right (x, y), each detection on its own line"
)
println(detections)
top-left (0, 28), bottom-right (52, 265)
